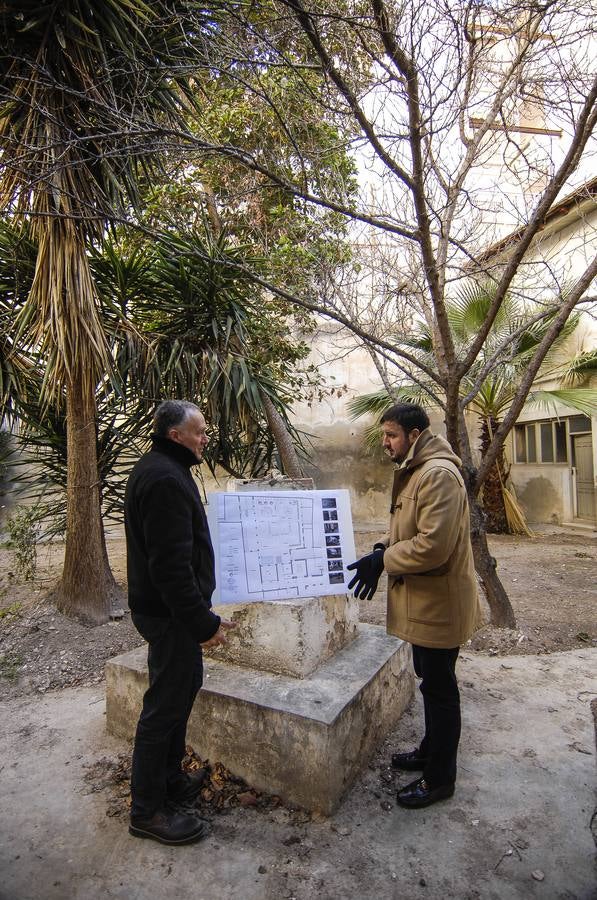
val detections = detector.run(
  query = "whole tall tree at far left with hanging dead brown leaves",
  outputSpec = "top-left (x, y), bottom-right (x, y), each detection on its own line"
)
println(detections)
top-left (0, 0), bottom-right (214, 622)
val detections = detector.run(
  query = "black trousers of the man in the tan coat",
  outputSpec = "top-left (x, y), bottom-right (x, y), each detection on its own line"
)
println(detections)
top-left (413, 644), bottom-right (460, 788)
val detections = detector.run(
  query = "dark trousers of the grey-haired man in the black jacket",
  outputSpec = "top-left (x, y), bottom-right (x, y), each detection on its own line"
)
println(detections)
top-left (131, 613), bottom-right (203, 818)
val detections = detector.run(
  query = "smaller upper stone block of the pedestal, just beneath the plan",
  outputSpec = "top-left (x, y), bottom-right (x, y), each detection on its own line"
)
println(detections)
top-left (209, 594), bottom-right (359, 678)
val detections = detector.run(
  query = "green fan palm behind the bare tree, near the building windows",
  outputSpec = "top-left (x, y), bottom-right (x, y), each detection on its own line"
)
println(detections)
top-left (350, 284), bottom-right (597, 534)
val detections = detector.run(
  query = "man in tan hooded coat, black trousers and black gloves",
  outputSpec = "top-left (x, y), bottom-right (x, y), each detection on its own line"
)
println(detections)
top-left (348, 403), bottom-right (481, 808)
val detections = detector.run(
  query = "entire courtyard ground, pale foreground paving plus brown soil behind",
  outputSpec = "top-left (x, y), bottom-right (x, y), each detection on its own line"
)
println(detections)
top-left (0, 529), bottom-right (597, 900)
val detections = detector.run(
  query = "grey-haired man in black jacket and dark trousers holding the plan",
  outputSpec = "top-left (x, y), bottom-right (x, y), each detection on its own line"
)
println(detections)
top-left (124, 400), bottom-right (232, 844)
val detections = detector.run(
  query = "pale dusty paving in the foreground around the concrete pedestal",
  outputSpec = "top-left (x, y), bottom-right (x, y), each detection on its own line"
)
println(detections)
top-left (0, 647), bottom-right (597, 900)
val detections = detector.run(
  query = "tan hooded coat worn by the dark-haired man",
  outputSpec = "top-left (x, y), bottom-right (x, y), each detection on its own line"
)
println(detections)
top-left (384, 428), bottom-right (482, 648)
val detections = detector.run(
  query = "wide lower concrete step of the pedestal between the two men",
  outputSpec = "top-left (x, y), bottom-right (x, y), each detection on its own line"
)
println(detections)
top-left (106, 624), bottom-right (414, 815)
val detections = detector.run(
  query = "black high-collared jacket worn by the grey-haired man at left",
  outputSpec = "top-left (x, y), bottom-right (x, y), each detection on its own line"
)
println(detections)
top-left (124, 435), bottom-right (220, 643)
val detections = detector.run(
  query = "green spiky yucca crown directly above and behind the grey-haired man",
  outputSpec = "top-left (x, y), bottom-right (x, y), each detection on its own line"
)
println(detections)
top-left (92, 229), bottom-right (307, 477)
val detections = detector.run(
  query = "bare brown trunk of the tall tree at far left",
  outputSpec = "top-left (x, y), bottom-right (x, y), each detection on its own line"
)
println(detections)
top-left (54, 372), bottom-right (122, 625)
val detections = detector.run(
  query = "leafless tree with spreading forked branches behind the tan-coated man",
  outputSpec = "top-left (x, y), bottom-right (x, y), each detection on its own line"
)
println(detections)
top-left (182, 0), bottom-right (597, 626)
